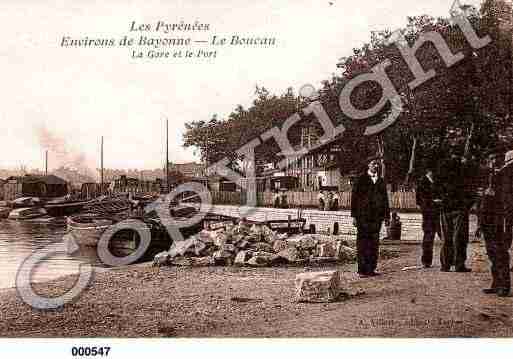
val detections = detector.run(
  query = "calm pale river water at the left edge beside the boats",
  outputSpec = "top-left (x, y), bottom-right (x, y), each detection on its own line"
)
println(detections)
top-left (0, 220), bottom-right (100, 288)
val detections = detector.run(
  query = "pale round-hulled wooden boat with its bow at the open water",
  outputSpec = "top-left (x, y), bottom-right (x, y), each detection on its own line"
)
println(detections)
top-left (67, 215), bottom-right (114, 247)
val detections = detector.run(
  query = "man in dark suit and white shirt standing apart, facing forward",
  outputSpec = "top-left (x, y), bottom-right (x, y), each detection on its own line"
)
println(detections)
top-left (351, 159), bottom-right (390, 277)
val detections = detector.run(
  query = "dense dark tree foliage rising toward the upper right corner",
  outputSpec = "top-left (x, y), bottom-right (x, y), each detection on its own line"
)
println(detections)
top-left (184, 0), bottom-right (513, 182)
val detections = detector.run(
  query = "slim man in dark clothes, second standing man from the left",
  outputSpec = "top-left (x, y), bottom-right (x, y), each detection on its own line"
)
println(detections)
top-left (416, 167), bottom-right (442, 268)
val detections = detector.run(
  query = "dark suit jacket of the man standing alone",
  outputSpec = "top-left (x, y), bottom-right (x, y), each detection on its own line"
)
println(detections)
top-left (351, 174), bottom-right (390, 222)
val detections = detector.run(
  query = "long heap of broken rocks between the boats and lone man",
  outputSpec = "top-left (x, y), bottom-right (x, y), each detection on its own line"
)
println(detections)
top-left (154, 224), bottom-right (356, 267)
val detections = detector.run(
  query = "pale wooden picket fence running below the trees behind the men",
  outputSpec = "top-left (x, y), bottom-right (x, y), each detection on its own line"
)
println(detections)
top-left (211, 191), bottom-right (417, 210)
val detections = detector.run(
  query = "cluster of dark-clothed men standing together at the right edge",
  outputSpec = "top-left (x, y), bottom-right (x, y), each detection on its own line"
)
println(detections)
top-left (416, 154), bottom-right (512, 297)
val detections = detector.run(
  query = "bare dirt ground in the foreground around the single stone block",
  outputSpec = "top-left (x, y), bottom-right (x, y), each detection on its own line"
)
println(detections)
top-left (0, 243), bottom-right (513, 337)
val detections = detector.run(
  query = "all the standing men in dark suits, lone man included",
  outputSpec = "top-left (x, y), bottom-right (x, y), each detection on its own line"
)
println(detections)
top-left (351, 155), bottom-right (513, 297)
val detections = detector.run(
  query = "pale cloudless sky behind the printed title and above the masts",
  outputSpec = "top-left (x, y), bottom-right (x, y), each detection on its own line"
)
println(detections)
top-left (0, 0), bottom-right (480, 174)
